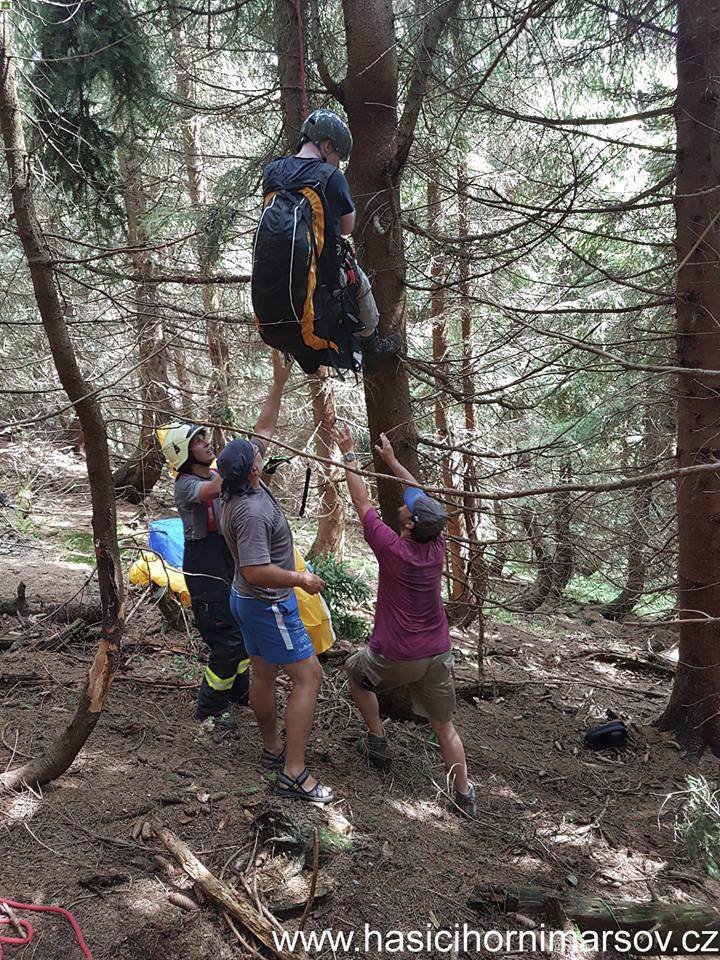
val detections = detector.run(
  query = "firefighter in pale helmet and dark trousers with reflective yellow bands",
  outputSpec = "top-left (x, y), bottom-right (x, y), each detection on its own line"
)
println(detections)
top-left (158, 423), bottom-right (249, 732)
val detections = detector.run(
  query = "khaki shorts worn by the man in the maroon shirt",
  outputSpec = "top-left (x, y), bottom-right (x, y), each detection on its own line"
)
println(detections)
top-left (345, 647), bottom-right (455, 723)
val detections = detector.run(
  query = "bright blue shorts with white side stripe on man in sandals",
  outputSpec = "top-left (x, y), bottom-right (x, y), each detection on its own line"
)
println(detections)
top-left (230, 588), bottom-right (315, 664)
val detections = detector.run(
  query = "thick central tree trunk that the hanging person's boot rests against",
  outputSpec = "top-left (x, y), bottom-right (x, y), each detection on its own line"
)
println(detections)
top-left (343, 0), bottom-right (420, 528)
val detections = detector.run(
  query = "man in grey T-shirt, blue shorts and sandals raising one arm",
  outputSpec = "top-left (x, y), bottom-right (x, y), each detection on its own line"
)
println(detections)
top-left (218, 351), bottom-right (333, 803)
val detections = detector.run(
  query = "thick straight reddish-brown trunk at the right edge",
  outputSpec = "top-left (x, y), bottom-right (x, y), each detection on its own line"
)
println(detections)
top-left (660, 0), bottom-right (720, 756)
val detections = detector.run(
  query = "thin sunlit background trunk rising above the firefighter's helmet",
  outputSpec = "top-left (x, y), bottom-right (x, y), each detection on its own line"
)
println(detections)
top-left (171, 10), bottom-right (232, 452)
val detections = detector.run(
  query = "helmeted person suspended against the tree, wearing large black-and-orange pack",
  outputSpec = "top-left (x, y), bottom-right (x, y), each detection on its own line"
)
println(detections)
top-left (252, 110), bottom-right (400, 373)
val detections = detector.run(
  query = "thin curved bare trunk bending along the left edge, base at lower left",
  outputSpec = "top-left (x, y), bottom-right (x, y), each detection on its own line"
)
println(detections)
top-left (0, 13), bottom-right (124, 789)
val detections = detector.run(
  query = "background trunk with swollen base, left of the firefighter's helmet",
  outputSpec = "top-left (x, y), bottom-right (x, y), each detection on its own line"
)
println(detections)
top-left (113, 142), bottom-right (174, 503)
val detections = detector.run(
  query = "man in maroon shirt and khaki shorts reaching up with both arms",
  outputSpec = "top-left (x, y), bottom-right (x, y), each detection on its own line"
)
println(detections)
top-left (337, 427), bottom-right (477, 817)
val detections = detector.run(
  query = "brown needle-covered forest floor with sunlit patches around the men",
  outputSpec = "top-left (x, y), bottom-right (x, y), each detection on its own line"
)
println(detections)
top-left (0, 451), bottom-right (720, 960)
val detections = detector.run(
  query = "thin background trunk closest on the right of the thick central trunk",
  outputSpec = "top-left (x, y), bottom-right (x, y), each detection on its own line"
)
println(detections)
top-left (427, 165), bottom-right (469, 600)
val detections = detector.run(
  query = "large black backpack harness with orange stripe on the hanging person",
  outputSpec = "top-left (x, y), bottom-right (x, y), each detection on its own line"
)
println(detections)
top-left (251, 163), bottom-right (362, 373)
